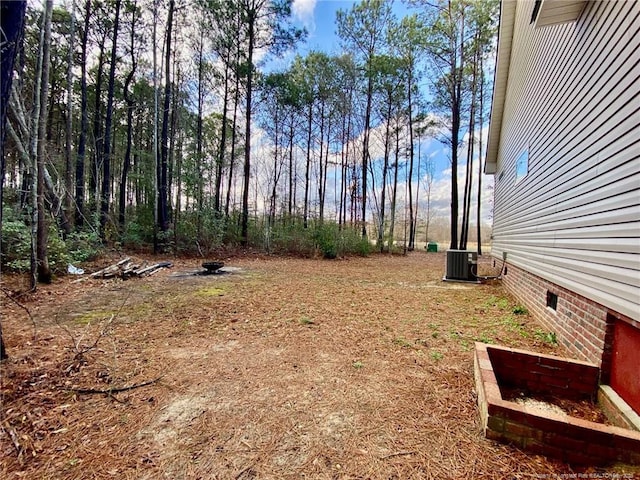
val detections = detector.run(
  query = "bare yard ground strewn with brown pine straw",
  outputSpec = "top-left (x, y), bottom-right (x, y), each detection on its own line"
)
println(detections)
top-left (0, 252), bottom-right (637, 480)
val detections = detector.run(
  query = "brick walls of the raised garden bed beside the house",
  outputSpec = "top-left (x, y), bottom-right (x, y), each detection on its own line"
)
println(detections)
top-left (474, 343), bottom-right (640, 465)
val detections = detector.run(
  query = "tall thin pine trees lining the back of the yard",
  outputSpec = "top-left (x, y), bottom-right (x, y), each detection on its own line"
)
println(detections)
top-left (2, 0), bottom-right (497, 288)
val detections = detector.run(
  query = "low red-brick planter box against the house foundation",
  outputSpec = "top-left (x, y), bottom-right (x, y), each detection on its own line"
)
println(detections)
top-left (474, 343), bottom-right (640, 465)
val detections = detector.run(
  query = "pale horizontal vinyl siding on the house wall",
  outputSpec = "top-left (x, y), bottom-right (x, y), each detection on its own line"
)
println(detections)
top-left (492, 2), bottom-right (640, 320)
